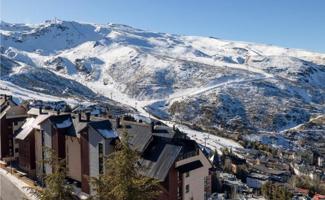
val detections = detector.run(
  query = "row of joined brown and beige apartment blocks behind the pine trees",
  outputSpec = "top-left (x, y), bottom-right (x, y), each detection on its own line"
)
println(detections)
top-left (10, 109), bottom-right (212, 200)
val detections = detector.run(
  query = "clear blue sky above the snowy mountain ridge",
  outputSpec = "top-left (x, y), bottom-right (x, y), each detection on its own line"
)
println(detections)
top-left (0, 0), bottom-right (325, 53)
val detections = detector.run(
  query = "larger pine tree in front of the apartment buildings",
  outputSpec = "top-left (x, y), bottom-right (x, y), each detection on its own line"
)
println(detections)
top-left (91, 133), bottom-right (160, 200)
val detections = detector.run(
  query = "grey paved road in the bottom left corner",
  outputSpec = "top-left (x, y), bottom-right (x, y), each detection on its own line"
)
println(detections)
top-left (0, 174), bottom-right (27, 200)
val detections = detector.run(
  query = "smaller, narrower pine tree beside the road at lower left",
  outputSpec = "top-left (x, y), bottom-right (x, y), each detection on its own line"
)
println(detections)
top-left (27, 148), bottom-right (76, 200)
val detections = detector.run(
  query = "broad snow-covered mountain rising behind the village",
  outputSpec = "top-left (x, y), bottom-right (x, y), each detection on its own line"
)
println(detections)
top-left (0, 20), bottom-right (325, 131)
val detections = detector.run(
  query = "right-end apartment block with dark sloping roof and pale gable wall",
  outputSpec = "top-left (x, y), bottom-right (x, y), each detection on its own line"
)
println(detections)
top-left (117, 121), bottom-right (212, 200)
